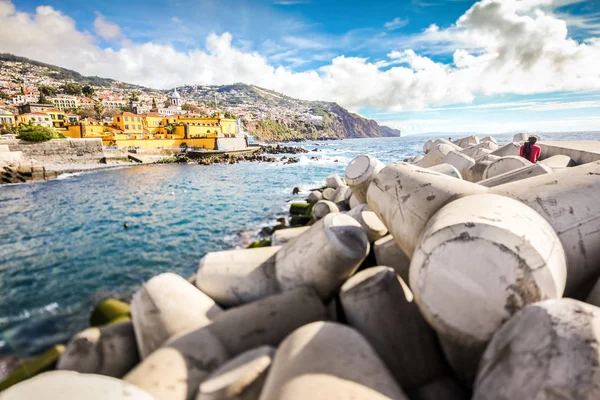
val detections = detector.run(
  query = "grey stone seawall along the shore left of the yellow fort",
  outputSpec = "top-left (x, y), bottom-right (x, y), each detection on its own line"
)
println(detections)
top-left (2, 139), bottom-right (104, 164)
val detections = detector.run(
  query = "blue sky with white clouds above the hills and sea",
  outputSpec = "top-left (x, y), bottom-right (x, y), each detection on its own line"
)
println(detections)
top-left (0, 0), bottom-right (600, 134)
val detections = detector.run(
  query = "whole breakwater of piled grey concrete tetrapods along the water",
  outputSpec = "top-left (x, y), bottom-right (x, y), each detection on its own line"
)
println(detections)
top-left (3, 133), bottom-right (600, 399)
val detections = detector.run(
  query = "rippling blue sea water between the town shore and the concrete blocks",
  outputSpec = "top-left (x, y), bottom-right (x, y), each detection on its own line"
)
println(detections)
top-left (0, 134), bottom-right (599, 356)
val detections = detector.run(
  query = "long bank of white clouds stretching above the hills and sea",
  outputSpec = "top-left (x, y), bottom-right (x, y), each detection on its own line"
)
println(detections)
top-left (0, 0), bottom-right (600, 116)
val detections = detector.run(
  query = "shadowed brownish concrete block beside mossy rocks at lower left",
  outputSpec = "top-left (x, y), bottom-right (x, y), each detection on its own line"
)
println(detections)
top-left (56, 321), bottom-right (140, 378)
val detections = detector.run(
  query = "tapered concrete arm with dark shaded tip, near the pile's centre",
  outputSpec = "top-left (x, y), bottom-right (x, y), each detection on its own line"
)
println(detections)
top-left (275, 213), bottom-right (370, 301)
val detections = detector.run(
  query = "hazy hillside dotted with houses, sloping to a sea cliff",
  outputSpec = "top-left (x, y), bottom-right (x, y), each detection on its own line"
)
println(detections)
top-left (0, 54), bottom-right (400, 140)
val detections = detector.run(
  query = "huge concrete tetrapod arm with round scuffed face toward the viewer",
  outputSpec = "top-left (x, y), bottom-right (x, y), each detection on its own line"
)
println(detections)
top-left (409, 194), bottom-right (567, 384)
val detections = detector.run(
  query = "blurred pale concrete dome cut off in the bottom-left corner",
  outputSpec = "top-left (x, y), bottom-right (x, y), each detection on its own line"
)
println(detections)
top-left (0, 371), bottom-right (155, 400)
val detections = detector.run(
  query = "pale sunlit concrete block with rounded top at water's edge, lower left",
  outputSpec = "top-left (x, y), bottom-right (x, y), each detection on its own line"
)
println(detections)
top-left (131, 273), bottom-right (221, 358)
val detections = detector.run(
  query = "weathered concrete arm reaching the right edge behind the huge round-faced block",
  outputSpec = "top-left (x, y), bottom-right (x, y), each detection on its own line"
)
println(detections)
top-left (490, 161), bottom-right (600, 296)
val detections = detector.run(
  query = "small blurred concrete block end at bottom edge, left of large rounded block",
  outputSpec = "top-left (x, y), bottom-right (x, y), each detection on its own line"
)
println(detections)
top-left (196, 346), bottom-right (275, 400)
